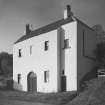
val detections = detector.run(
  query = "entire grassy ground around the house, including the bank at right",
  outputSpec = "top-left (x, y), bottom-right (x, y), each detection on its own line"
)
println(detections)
top-left (0, 77), bottom-right (105, 105)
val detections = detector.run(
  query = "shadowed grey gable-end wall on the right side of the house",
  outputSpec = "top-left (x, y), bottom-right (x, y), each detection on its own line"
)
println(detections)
top-left (77, 22), bottom-right (97, 89)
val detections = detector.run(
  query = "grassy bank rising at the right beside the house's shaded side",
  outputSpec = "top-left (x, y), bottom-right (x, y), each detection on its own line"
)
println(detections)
top-left (66, 77), bottom-right (105, 105)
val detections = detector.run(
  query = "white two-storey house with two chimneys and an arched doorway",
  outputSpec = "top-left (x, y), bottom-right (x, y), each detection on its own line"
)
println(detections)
top-left (13, 5), bottom-right (97, 93)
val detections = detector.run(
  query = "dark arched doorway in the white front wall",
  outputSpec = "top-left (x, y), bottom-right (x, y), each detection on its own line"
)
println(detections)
top-left (27, 72), bottom-right (37, 92)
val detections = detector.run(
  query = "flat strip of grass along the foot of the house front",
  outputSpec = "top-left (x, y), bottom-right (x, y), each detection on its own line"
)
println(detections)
top-left (0, 90), bottom-right (76, 105)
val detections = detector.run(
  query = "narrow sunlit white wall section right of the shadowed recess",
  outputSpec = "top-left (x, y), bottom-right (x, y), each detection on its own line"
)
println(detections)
top-left (62, 21), bottom-right (77, 91)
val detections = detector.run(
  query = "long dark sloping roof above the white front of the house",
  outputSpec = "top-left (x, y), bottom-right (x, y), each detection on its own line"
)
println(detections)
top-left (14, 18), bottom-right (73, 44)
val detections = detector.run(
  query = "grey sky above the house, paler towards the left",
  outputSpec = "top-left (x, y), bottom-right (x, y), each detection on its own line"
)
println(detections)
top-left (0, 0), bottom-right (105, 53)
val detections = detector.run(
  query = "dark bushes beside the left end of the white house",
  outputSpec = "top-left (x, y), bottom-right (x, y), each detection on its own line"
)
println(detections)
top-left (0, 52), bottom-right (13, 89)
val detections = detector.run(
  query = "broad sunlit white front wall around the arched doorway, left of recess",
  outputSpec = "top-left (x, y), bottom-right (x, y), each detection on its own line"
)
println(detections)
top-left (13, 30), bottom-right (60, 92)
